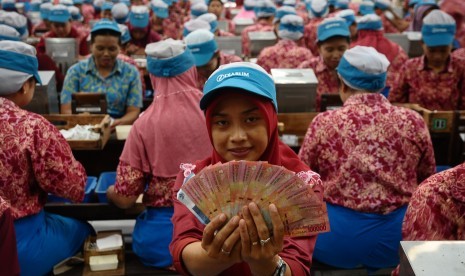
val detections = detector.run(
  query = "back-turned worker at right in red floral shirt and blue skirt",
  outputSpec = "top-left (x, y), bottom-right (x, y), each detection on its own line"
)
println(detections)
top-left (299, 46), bottom-right (435, 272)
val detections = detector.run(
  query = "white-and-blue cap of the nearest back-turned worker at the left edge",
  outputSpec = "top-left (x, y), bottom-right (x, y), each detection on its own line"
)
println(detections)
top-left (0, 40), bottom-right (42, 95)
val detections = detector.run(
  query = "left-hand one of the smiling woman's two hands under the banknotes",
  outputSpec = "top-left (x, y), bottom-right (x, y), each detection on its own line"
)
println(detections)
top-left (201, 214), bottom-right (242, 265)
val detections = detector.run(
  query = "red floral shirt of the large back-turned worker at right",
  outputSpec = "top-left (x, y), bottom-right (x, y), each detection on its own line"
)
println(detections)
top-left (299, 93), bottom-right (435, 214)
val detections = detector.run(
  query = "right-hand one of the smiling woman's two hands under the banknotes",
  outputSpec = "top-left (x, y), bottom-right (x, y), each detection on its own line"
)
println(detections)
top-left (239, 202), bottom-right (284, 275)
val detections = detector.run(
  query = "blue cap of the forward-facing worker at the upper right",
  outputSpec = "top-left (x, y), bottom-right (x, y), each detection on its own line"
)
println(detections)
top-left (421, 10), bottom-right (456, 47)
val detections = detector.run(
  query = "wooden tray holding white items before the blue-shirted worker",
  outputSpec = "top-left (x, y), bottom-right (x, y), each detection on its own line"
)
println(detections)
top-left (43, 114), bottom-right (111, 150)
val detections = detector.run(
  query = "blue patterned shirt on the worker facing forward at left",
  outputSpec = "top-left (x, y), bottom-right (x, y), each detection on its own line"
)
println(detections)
top-left (61, 56), bottom-right (142, 118)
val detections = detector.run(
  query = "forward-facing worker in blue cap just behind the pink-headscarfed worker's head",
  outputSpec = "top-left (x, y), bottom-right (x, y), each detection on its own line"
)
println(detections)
top-left (126, 6), bottom-right (161, 56)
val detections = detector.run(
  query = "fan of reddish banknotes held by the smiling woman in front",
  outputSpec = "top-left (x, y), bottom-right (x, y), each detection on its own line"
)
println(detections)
top-left (177, 161), bottom-right (329, 237)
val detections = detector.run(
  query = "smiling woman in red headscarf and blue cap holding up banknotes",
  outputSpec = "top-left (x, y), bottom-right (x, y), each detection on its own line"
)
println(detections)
top-left (170, 62), bottom-right (323, 275)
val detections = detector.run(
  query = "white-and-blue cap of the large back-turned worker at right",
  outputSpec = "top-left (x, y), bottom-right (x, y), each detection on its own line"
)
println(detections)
top-left (336, 46), bottom-right (389, 92)
